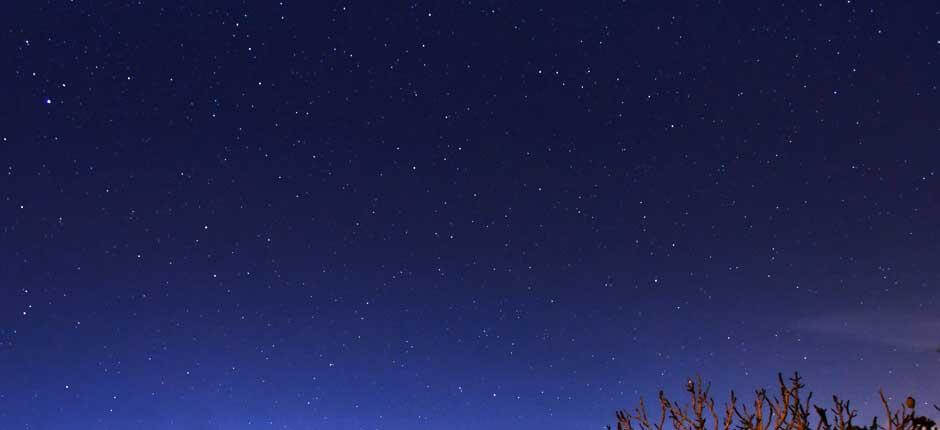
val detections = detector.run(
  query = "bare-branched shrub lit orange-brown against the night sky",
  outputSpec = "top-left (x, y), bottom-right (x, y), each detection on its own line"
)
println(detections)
top-left (607, 373), bottom-right (940, 430)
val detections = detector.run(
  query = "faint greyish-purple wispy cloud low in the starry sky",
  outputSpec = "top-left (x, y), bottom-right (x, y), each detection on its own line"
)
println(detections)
top-left (793, 312), bottom-right (940, 351)
